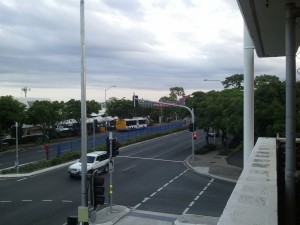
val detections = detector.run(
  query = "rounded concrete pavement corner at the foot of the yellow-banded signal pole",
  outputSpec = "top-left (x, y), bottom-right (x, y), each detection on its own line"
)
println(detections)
top-left (90, 205), bottom-right (130, 225)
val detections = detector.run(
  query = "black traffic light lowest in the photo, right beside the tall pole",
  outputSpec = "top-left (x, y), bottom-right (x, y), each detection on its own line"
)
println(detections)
top-left (92, 174), bottom-right (105, 210)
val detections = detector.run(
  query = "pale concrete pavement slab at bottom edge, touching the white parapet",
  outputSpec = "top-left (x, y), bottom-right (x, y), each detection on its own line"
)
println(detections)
top-left (174, 214), bottom-right (219, 225)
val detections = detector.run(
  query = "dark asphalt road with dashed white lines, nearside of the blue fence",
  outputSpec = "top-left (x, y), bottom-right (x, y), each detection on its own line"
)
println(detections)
top-left (0, 131), bottom-right (234, 225)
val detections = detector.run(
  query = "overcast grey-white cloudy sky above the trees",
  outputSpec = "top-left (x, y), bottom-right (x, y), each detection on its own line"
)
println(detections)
top-left (0, 0), bottom-right (285, 101)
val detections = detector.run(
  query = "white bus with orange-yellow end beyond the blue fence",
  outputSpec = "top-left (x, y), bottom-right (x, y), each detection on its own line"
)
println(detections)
top-left (116, 117), bottom-right (148, 131)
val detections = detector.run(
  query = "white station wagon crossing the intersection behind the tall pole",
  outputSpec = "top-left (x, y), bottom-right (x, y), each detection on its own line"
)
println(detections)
top-left (68, 151), bottom-right (109, 177)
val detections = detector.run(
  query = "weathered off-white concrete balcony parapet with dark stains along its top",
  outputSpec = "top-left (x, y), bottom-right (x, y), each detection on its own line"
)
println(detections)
top-left (218, 138), bottom-right (278, 225)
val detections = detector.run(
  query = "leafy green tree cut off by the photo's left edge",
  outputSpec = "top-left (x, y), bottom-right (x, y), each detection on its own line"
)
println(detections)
top-left (0, 96), bottom-right (26, 132)
